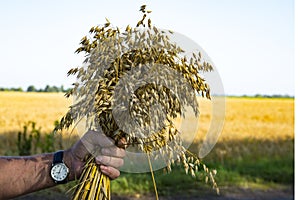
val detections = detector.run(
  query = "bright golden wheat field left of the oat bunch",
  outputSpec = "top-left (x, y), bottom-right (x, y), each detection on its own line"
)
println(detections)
top-left (0, 92), bottom-right (72, 133)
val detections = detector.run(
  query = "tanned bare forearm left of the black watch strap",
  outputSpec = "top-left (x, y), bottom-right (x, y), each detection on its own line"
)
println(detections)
top-left (0, 153), bottom-right (55, 199)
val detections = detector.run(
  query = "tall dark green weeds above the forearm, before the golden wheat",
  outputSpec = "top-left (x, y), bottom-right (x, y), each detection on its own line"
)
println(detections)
top-left (17, 121), bottom-right (62, 156)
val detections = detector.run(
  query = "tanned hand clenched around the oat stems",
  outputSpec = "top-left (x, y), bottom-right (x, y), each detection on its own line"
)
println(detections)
top-left (64, 131), bottom-right (125, 179)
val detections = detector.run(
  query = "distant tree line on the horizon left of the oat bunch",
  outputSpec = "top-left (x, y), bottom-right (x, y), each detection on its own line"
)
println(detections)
top-left (0, 85), bottom-right (70, 92)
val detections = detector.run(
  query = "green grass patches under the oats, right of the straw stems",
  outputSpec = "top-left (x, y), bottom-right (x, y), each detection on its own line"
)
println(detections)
top-left (111, 166), bottom-right (217, 196)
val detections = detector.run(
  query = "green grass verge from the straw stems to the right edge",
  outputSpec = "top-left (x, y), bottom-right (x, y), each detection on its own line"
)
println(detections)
top-left (112, 139), bottom-right (294, 196)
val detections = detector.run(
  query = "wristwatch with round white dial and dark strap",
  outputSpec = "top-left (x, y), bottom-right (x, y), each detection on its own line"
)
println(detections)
top-left (50, 151), bottom-right (69, 184)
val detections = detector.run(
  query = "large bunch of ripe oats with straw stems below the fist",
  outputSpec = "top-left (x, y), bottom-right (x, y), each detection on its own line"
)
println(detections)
top-left (56, 5), bottom-right (217, 199)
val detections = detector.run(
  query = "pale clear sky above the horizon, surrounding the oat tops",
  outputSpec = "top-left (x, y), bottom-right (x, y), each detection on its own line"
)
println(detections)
top-left (0, 0), bottom-right (295, 95)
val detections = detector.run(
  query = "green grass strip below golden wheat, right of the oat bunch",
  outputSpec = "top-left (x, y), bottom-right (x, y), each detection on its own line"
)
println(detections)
top-left (204, 138), bottom-right (294, 185)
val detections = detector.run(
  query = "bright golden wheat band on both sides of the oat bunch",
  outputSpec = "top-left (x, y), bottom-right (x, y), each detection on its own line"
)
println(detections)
top-left (0, 92), bottom-right (294, 141)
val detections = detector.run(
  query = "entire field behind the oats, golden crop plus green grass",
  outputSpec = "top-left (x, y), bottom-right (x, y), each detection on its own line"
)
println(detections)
top-left (0, 92), bottom-right (294, 199)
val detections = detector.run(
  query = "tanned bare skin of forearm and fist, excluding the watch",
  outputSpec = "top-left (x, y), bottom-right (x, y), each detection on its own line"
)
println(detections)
top-left (0, 131), bottom-right (125, 199)
